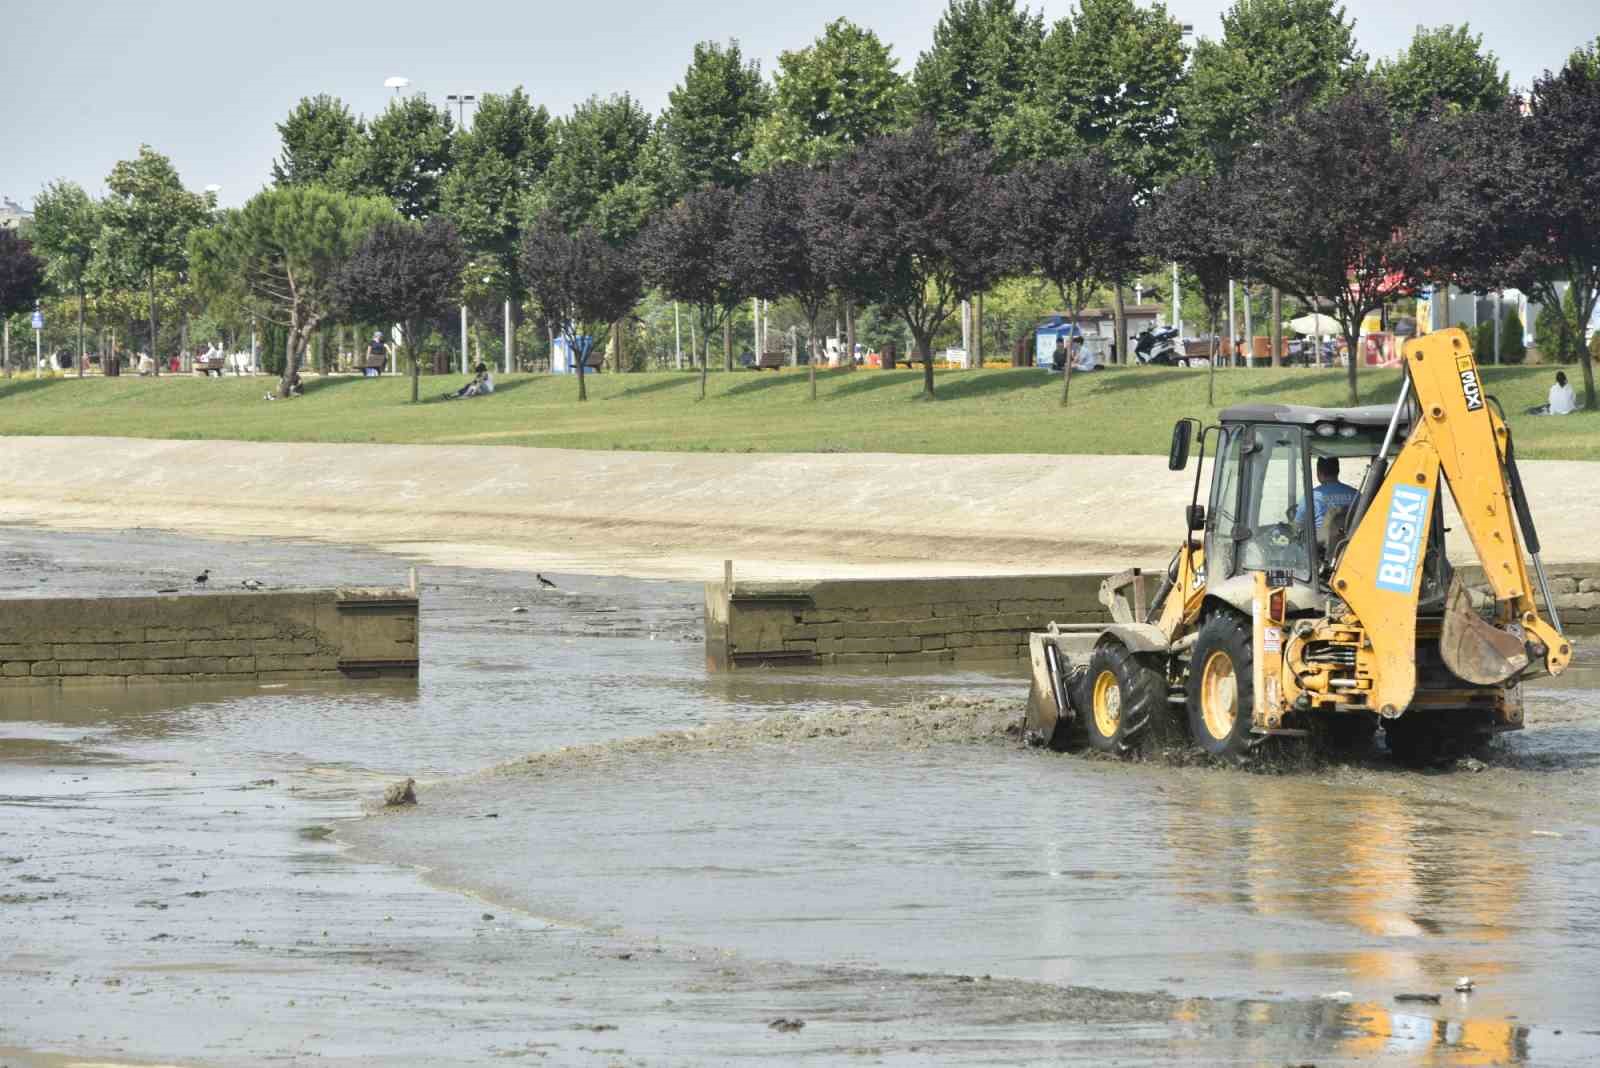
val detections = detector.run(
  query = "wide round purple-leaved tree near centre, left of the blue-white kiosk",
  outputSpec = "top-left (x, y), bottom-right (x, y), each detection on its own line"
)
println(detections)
top-left (808, 122), bottom-right (1019, 400)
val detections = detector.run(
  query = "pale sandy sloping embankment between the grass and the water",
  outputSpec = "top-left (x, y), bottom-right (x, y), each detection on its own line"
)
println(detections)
top-left (0, 436), bottom-right (1600, 579)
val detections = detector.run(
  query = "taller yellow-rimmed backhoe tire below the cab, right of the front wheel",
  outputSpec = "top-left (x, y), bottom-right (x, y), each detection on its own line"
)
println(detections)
top-left (1186, 611), bottom-right (1256, 763)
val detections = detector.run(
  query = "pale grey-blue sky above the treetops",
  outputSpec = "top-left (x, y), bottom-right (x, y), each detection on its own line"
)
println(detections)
top-left (0, 0), bottom-right (1600, 206)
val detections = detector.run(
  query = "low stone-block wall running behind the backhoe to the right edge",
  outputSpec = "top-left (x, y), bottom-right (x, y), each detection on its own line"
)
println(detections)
top-left (706, 564), bottom-right (1600, 670)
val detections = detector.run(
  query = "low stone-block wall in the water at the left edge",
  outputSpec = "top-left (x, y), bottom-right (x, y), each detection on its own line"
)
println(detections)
top-left (0, 588), bottom-right (418, 686)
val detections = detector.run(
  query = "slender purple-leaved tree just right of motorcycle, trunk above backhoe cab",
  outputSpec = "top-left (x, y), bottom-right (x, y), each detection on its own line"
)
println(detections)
top-left (1139, 174), bottom-right (1235, 404)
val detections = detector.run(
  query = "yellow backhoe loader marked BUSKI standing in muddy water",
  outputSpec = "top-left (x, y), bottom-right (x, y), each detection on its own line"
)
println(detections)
top-left (1024, 329), bottom-right (1571, 763)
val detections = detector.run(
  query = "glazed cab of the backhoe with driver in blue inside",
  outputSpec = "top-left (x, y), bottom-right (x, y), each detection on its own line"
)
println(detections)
top-left (1171, 404), bottom-right (1443, 611)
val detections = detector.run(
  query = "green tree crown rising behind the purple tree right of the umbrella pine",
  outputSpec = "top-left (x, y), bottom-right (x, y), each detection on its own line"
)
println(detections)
top-left (328, 96), bottom-right (454, 219)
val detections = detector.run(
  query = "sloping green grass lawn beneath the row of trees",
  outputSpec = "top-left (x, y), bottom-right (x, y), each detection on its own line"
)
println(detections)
top-left (0, 368), bottom-right (1600, 460)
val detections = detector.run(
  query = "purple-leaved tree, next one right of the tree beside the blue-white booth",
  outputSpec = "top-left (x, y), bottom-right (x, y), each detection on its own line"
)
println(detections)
top-left (638, 185), bottom-right (750, 400)
